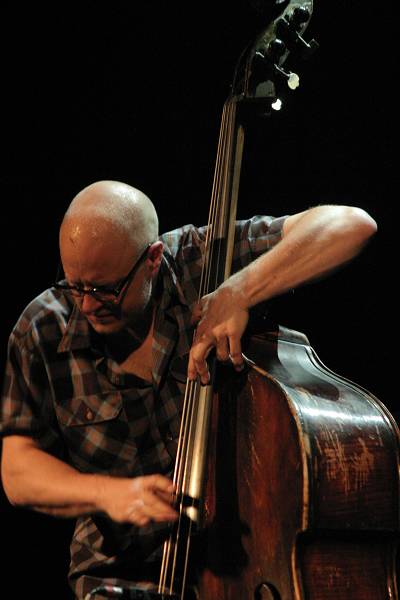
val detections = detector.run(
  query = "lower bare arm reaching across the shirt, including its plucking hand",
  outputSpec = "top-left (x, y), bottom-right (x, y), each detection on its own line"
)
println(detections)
top-left (1, 436), bottom-right (176, 525)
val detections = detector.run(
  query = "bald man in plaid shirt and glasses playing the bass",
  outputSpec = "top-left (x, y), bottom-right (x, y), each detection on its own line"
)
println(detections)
top-left (0, 181), bottom-right (376, 598)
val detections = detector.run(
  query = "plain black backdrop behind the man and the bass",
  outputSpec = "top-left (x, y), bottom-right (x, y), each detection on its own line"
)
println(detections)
top-left (1, 0), bottom-right (397, 598)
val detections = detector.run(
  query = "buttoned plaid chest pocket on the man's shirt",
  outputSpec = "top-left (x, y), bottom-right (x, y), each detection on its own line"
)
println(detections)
top-left (56, 391), bottom-right (122, 427)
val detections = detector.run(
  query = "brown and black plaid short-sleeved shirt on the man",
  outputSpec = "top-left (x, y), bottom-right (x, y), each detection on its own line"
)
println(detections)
top-left (0, 217), bottom-right (284, 598)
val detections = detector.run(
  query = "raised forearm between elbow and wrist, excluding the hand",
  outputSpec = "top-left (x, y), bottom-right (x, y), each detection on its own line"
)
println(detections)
top-left (233, 206), bottom-right (376, 307)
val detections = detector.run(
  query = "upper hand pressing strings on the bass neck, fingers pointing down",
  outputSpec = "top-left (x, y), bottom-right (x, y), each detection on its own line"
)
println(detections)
top-left (188, 281), bottom-right (249, 385)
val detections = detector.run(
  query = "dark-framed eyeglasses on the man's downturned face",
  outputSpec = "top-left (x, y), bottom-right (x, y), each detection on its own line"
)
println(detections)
top-left (53, 242), bottom-right (153, 304)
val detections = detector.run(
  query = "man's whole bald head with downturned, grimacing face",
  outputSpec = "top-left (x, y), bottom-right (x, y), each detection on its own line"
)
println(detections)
top-left (56, 181), bottom-right (163, 335)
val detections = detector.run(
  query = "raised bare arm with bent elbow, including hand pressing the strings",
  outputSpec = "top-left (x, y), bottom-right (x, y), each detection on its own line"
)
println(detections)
top-left (188, 206), bottom-right (376, 383)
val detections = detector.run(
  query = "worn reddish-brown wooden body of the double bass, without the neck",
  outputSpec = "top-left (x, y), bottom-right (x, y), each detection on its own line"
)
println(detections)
top-left (199, 328), bottom-right (399, 600)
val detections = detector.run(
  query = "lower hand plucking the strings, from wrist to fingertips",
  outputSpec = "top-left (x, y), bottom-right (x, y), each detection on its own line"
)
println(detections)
top-left (98, 475), bottom-right (178, 526)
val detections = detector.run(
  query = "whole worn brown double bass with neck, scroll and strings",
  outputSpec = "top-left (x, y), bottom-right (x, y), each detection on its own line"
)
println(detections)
top-left (97, 0), bottom-right (400, 600)
